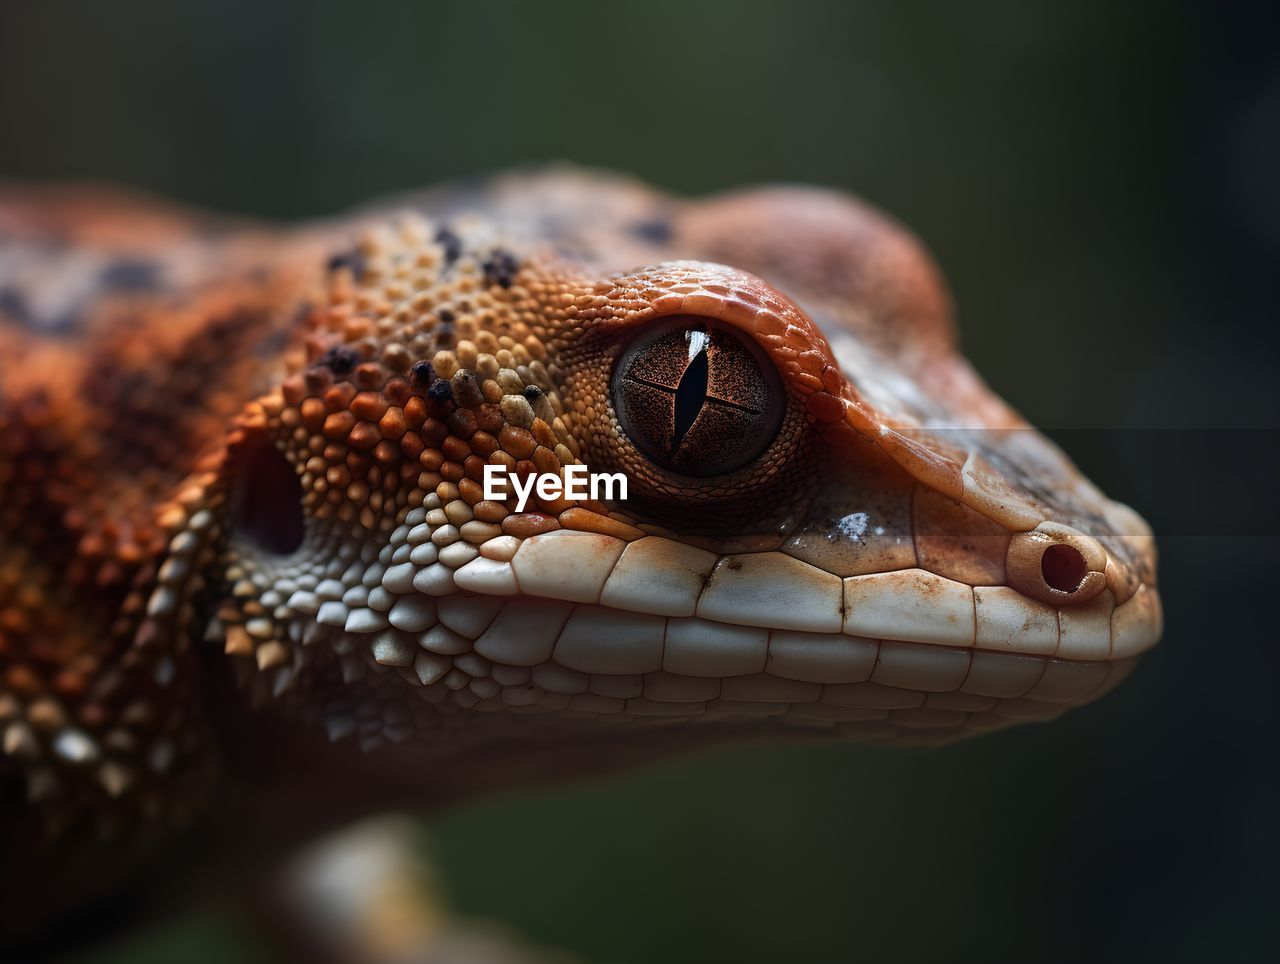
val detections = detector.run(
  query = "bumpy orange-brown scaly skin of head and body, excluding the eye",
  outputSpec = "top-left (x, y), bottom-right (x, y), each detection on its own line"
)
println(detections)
top-left (0, 170), bottom-right (1160, 928)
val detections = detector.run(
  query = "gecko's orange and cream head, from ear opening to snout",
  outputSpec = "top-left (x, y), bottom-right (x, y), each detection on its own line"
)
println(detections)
top-left (185, 195), bottom-right (1160, 773)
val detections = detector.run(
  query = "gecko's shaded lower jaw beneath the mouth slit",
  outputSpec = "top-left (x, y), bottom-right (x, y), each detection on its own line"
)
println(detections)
top-left (288, 609), bottom-right (1138, 743)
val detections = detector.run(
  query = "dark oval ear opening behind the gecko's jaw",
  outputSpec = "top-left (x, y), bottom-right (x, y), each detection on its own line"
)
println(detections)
top-left (230, 438), bottom-right (305, 556)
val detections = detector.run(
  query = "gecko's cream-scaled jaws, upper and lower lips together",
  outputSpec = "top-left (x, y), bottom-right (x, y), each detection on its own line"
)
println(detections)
top-left (222, 471), bottom-right (1158, 748)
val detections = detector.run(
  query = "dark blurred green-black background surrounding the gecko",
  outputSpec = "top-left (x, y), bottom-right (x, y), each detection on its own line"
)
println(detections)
top-left (0, 0), bottom-right (1280, 963)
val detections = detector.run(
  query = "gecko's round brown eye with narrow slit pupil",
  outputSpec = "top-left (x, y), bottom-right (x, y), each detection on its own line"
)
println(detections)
top-left (612, 316), bottom-right (786, 479)
